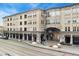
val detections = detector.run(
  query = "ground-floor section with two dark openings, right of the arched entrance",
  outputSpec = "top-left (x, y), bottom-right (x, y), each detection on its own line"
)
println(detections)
top-left (60, 32), bottom-right (79, 45)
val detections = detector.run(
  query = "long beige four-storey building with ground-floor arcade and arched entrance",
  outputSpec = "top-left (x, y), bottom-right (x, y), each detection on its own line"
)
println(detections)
top-left (3, 4), bottom-right (79, 44)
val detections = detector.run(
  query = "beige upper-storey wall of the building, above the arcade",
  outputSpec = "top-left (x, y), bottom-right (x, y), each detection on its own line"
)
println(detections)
top-left (3, 4), bottom-right (79, 31)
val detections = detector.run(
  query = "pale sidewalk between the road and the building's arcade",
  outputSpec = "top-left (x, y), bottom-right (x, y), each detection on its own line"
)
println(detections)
top-left (23, 41), bottom-right (79, 56)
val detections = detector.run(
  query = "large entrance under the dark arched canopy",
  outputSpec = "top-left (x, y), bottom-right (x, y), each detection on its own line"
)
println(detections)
top-left (46, 27), bottom-right (60, 41)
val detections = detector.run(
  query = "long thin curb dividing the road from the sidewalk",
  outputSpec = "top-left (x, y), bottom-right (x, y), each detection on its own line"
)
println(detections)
top-left (24, 42), bottom-right (79, 56)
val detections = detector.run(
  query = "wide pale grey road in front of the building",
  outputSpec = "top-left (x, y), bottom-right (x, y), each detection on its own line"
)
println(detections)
top-left (0, 39), bottom-right (77, 56)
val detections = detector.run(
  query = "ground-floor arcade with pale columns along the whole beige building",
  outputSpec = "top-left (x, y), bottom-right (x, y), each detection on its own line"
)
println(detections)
top-left (4, 32), bottom-right (79, 45)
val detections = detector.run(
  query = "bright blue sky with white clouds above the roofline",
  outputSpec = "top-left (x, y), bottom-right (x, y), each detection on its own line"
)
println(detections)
top-left (0, 3), bottom-right (71, 26)
